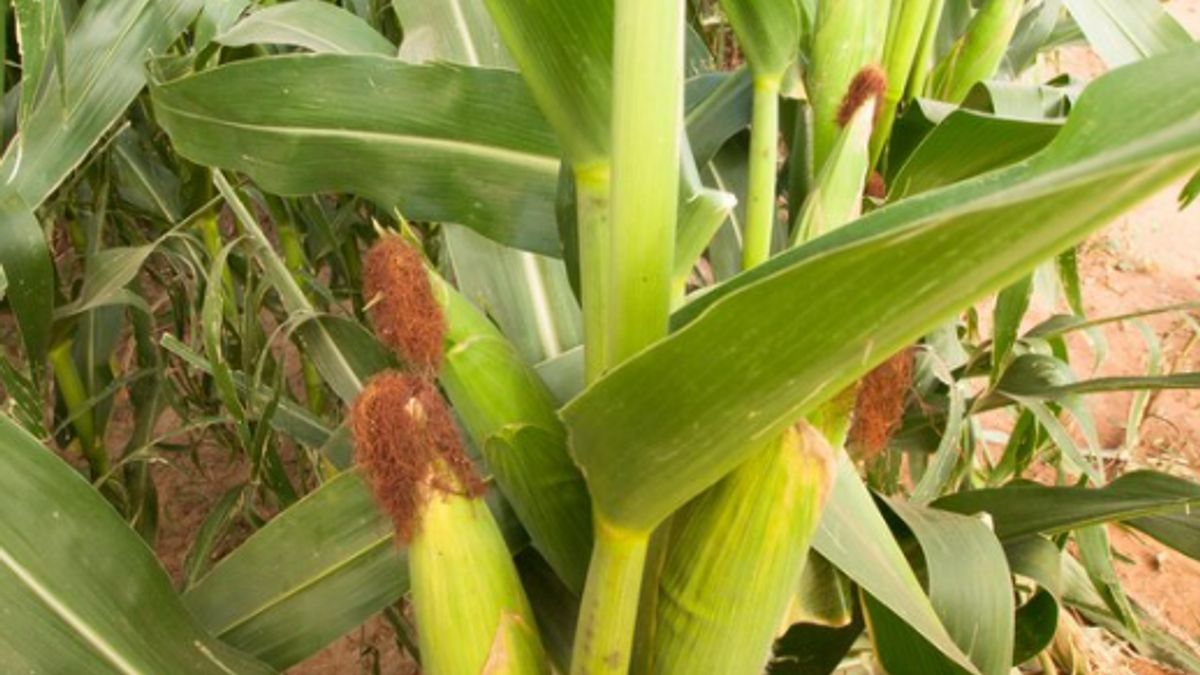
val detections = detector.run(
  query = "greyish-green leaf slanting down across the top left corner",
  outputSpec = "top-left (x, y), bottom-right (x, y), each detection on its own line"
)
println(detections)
top-left (0, 0), bottom-right (200, 208)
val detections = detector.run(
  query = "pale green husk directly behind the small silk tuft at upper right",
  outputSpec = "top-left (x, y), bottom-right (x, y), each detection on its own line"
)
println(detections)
top-left (808, 0), bottom-right (890, 175)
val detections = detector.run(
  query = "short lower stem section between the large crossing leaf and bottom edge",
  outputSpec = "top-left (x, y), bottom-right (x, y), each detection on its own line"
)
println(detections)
top-left (571, 518), bottom-right (649, 675)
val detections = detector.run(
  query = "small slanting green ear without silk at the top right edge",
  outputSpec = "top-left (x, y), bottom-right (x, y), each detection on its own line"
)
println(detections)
top-left (934, 0), bottom-right (1025, 103)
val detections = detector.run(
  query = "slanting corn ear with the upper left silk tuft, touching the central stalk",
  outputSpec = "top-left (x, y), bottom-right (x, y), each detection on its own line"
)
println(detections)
top-left (365, 237), bottom-right (592, 593)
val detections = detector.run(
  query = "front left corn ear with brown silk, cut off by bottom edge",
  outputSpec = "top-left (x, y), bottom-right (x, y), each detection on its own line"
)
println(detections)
top-left (350, 372), bottom-right (548, 675)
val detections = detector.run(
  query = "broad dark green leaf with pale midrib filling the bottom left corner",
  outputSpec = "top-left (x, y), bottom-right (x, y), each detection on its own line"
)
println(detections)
top-left (0, 417), bottom-right (271, 675)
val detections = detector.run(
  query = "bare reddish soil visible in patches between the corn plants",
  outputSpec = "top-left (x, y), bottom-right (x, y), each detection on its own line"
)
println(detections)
top-left (140, 6), bottom-right (1200, 675)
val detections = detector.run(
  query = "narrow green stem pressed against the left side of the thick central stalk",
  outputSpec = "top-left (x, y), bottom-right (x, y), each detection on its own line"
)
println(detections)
top-left (575, 163), bottom-right (612, 382)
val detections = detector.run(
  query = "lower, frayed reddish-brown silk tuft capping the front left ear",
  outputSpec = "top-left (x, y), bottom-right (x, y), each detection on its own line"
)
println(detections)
top-left (350, 371), bottom-right (484, 544)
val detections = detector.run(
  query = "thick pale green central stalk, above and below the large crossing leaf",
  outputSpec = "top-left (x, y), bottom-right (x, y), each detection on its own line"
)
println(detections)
top-left (571, 0), bottom-right (686, 675)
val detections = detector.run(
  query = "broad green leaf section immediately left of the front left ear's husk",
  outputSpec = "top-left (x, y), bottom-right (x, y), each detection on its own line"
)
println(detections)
top-left (184, 472), bottom-right (408, 669)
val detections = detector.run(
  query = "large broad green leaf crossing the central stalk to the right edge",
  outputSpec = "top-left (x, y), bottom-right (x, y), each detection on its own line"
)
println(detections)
top-left (563, 46), bottom-right (1200, 528)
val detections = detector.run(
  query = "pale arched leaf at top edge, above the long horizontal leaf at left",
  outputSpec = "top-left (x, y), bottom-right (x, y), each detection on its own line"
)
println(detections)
top-left (216, 0), bottom-right (396, 56)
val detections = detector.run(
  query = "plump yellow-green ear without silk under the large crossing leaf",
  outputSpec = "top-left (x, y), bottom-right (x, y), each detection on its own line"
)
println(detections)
top-left (648, 423), bottom-right (834, 675)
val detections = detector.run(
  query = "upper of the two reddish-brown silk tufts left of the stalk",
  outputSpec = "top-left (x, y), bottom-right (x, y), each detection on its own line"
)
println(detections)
top-left (362, 235), bottom-right (446, 375)
